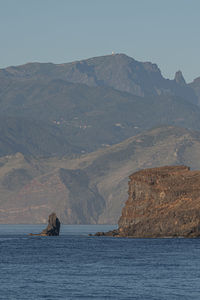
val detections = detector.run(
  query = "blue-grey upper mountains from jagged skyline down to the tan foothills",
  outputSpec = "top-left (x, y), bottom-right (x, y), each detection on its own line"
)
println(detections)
top-left (0, 54), bottom-right (200, 156)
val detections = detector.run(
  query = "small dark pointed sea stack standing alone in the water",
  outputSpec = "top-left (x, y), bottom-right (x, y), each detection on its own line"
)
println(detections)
top-left (30, 213), bottom-right (60, 236)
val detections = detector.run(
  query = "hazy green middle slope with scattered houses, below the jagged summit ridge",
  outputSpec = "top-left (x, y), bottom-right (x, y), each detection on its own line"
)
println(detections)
top-left (0, 80), bottom-right (200, 155)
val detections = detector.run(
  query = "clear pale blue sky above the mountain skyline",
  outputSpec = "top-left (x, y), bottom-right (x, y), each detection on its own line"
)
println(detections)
top-left (0, 0), bottom-right (200, 82)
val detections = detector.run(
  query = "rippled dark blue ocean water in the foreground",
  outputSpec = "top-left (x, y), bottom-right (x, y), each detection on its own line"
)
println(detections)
top-left (0, 225), bottom-right (200, 300)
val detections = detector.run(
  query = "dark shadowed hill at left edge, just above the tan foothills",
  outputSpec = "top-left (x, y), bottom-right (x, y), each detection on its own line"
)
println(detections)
top-left (0, 116), bottom-right (81, 156)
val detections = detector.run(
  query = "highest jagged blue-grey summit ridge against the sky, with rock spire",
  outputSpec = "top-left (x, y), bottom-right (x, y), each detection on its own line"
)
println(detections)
top-left (0, 54), bottom-right (197, 103)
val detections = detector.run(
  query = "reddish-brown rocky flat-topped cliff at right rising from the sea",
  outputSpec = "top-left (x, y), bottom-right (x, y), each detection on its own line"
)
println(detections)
top-left (117, 166), bottom-right (200, 237)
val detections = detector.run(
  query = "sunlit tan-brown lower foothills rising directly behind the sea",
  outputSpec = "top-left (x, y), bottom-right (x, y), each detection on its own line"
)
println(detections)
top-left (0, 127), bottom-right (200, 224)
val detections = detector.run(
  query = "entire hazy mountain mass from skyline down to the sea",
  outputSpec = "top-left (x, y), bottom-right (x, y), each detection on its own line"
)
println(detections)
top-left (0, 54), bottom-right (200, 224)
